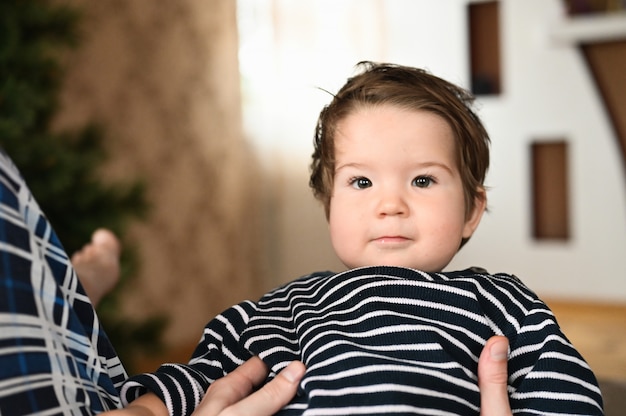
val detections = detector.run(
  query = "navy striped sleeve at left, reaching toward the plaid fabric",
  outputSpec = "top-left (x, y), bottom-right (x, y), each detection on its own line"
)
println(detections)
top-left (121, 302), bottom-right (256, 416)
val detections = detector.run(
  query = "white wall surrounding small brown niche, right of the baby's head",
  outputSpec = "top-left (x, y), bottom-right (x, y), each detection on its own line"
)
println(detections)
top-left (448, 0), bottom-right (626, 301)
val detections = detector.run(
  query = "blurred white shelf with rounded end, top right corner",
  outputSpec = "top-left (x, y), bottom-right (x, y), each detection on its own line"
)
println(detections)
top-left (551, 12), bottom-right (626, 44)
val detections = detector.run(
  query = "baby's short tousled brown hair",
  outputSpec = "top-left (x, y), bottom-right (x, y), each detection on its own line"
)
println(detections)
top-left (309, 61), bottom-right (489, 231)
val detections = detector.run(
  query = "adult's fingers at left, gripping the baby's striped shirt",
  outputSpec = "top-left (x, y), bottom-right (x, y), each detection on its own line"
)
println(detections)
top-left (193, 357), bottom-right (305, 416)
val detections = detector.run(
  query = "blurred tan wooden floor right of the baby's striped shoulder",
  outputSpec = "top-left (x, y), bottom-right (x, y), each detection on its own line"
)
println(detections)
top-left (546, 300), bottom-right (626, 381)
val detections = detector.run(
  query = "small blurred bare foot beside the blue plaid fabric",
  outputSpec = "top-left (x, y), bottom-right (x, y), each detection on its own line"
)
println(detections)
top-left (72, 228), bottom-right (122, 307)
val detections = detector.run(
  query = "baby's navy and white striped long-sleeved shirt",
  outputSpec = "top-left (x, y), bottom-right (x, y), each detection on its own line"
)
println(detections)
top-left (121, 267), bottom-right (603, 415)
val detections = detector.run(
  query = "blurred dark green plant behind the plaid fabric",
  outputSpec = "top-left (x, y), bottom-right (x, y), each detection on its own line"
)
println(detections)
top-left (0, 0), bottom-right (166, 372)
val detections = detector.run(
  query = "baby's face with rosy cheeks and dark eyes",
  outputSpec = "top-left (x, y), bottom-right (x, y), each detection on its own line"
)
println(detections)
top-left (329, 105), bottom-right (484, 272)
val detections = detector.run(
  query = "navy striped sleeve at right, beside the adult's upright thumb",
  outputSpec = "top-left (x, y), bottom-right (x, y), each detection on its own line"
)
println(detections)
top-left (509, 302), bottom-right (603, 415)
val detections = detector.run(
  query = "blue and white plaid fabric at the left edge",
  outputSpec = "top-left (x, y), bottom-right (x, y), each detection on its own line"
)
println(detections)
top-left (0, 151), bottom-right (127, 416)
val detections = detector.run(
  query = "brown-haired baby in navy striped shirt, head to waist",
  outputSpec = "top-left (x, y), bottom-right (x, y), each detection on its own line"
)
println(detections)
top-left (116, 62), bottom-right (603, 415)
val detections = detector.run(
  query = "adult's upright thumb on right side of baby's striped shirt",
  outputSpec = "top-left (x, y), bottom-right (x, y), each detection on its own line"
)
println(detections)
top-left (478, 336), bottom-right (512, 416)
